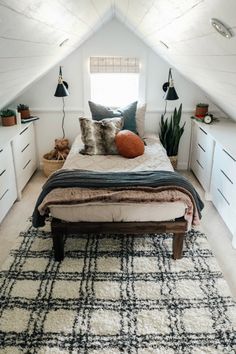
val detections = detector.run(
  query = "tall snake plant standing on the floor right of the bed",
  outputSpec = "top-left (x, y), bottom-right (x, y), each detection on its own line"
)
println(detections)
top-left (159, 103), bottom-right (185, 169)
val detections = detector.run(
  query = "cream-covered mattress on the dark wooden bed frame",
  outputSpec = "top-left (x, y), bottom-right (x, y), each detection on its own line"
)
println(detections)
top-left (50, 135), bottom-right (187, 222)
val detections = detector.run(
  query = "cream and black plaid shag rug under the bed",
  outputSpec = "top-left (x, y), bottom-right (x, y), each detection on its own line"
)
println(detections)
top-left (0, 227), bottom-right (236, 354)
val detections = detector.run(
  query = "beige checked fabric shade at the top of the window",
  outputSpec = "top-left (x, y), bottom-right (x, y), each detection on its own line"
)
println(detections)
top-left (90, 57), bottom-right (140, 74)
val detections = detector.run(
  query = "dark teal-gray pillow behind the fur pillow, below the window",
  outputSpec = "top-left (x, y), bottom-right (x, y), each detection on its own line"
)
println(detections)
top-left (88, 101), bottom-right (138, 133)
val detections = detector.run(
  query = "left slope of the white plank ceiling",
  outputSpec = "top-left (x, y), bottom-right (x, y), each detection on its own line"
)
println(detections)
top-left (0, 0), bottom-right (114, 107)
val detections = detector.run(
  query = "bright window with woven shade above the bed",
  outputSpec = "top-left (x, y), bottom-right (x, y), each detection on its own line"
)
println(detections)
top-left (90, 57), bottom-right (139, 107)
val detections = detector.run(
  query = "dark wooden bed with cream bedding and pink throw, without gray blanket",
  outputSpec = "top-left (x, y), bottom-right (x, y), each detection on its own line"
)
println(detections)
top-left (32, 135), bottom-right (203, 261)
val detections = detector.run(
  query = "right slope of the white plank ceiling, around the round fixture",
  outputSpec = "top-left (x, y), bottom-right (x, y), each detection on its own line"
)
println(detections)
top-left (115, 0), bottom-right (236, 119)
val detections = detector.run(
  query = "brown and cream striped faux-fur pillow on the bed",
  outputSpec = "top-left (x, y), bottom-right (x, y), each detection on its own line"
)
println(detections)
top-left (79, 117), bottom-right (124, 155)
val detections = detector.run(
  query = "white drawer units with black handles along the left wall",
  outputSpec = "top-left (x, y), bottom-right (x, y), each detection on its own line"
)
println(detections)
top-left (0, 123), bottom-right (37, 222)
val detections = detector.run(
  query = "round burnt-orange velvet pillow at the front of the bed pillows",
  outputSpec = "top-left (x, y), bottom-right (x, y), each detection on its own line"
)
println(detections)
top-left (115, 130), bottom-right (144, 158)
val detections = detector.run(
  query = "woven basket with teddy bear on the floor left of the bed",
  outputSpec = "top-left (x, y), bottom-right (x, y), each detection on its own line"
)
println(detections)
top-left (43, 139), bottom-right (70, 177)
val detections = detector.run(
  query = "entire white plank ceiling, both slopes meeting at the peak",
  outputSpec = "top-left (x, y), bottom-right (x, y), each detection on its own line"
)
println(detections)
top-left (0, 0), bottom-right (236, 119)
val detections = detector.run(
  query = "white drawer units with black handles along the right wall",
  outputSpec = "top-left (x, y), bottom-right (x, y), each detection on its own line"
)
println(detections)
top-left (190, 118), bottom-right (236, 248)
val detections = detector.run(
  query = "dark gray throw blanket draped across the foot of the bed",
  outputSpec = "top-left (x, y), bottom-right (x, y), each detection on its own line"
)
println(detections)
top-left (32, 170), bottom-right (204, 227)
